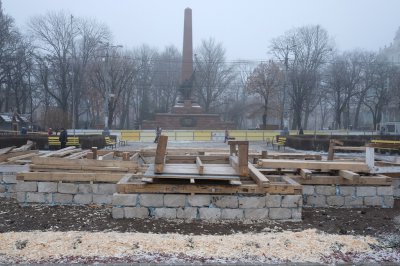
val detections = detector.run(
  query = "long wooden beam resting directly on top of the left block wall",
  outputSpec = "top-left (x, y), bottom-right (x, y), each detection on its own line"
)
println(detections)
top-left (17, 172), bottom-right (124, 183)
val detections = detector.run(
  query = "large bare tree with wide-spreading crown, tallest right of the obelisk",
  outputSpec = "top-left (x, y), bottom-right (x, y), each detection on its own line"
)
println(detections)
top-left (271, 25), bottom-right (333, 128)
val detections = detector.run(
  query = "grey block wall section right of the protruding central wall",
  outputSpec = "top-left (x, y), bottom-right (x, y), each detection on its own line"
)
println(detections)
top-left (303, 185), bottom-right (394, 208)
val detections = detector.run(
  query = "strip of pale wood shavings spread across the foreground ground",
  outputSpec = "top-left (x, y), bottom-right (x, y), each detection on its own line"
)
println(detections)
top-left (0, 229), bottom-right (400, 263)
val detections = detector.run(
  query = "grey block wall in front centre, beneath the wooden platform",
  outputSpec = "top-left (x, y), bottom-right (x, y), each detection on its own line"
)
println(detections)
top-left (112, 193), bottom-right (303, 221)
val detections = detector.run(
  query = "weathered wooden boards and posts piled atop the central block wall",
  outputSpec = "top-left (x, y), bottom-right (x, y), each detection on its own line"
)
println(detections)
top-left (117, 136), bottom-right (302, 194)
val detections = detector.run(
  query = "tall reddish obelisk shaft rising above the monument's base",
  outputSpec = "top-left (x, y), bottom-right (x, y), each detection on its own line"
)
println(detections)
top-left (181, 8), bottom-right (193, 84)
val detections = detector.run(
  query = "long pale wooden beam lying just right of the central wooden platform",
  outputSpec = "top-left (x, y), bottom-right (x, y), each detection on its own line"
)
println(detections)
top-left (258, 159), bottom-right (370, 173)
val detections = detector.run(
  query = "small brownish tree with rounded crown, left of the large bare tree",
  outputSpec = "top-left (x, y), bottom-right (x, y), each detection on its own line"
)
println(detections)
top-left (246, 61), bottom-right (284, 129)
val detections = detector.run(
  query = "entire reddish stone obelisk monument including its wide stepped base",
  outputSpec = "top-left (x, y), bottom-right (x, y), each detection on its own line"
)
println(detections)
top-left (142, 8), bottom-right (234, 130)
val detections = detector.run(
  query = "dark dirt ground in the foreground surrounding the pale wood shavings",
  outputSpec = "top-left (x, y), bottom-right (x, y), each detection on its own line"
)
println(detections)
top-left (0, 198), bottom-right (400, 264)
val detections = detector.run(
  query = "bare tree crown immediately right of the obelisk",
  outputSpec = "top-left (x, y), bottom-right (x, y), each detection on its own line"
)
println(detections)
top-left (195, 39), bottom-right (235, 113)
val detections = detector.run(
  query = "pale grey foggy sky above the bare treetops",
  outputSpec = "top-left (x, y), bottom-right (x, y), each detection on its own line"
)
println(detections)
top-left (2, 0), bottom-right (400, 60)
